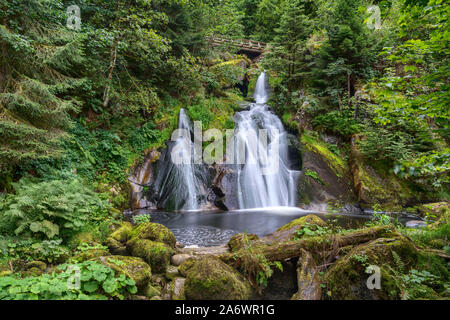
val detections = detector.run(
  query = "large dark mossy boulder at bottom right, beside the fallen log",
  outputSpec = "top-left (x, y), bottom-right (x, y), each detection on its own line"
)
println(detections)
top-left (324, 235), bottom-right (418, 300)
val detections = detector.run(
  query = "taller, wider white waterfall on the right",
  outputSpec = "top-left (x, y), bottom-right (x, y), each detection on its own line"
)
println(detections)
top-left (235, 72), bottom-right (299, 209)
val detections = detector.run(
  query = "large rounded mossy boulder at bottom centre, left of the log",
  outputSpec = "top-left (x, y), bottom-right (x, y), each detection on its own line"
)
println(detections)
top-left (179, 256), bottom-right (252, 300)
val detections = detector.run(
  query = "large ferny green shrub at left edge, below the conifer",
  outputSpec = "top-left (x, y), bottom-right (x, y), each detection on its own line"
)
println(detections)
top-left (0, 179), bottom-right (102, 239)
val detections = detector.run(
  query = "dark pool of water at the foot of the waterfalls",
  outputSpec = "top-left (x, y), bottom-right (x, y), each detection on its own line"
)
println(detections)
top-left (125, 207), bottom-right (404, 247)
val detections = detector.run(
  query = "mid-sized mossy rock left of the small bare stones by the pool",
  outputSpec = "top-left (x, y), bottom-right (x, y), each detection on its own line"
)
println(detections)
top-left (127, 239), bottom-right (175, 273)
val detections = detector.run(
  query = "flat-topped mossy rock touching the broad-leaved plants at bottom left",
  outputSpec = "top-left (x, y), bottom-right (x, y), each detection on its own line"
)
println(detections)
top-left (95, 256), bottom-right (152, 289)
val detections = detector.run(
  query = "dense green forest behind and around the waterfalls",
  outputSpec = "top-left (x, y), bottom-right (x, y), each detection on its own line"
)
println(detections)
top-left (0, 0), bottom-right (450, 300)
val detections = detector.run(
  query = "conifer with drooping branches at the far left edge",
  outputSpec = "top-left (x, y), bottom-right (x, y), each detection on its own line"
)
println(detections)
top-left (0, 0), bottom-right (85, 181)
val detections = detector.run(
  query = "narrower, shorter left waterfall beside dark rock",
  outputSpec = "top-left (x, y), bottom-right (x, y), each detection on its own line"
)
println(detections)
top-left (155, 109), bottom-right (205, 210)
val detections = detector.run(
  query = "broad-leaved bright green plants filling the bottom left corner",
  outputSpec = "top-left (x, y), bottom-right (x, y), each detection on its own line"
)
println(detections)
top-left (0, 261), bottom-right (137, 300)
